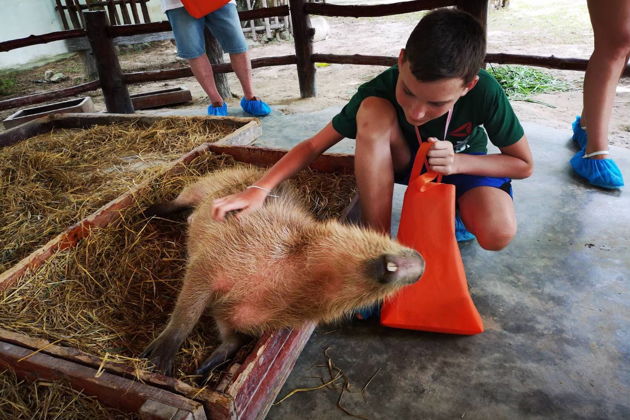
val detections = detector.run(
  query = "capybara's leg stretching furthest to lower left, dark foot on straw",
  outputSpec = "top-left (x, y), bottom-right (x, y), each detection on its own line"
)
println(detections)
top-left (140, 278), bottom-right (210, 376)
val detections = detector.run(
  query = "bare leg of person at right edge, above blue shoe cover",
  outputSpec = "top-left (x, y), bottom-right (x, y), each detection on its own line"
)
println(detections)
top-left (582, 0), bottom-right (630, 159)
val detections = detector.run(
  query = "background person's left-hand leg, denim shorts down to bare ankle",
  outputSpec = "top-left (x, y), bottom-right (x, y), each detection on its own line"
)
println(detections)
top-left (166, 7), bottom-right (223, 107)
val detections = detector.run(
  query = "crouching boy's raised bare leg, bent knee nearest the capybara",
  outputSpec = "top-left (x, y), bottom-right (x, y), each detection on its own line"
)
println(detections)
top-left (354, 98), bottom-right (412, 235)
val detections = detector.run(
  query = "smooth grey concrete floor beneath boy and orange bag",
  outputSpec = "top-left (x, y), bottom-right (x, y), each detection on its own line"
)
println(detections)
top-left (149, 108), bottom-right (630, 420)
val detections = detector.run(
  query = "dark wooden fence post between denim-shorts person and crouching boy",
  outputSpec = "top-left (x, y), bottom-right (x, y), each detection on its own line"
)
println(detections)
top-left (289, 0), bottom-right (316, 98)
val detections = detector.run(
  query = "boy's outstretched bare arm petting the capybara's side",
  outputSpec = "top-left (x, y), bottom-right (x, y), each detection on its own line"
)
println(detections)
top-left (212, 123), bottom-right (343, 220)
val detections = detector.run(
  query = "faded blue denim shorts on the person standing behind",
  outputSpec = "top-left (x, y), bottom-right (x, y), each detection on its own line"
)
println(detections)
top-left (166, 3), bottom-right (247, 60)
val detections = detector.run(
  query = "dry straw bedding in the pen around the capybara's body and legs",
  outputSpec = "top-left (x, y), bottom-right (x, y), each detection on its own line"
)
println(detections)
top-left (0, 153), bottom-right (355, 390)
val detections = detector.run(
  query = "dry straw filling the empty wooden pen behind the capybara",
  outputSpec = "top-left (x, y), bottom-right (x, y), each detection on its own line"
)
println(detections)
top-left (0, 118), bottom-right (237, 272)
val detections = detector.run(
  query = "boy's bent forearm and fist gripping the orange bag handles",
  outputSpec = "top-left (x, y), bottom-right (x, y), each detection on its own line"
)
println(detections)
top-left (428, 136), bottom-right (534, 179)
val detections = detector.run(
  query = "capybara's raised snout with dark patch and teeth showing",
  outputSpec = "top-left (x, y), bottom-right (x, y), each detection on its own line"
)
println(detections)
top-left (368, 249), bottom-right (424, 285)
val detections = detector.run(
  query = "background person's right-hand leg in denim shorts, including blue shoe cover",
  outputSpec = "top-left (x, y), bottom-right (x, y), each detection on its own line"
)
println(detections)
top-left (205, 3), bottom-right (271, 116)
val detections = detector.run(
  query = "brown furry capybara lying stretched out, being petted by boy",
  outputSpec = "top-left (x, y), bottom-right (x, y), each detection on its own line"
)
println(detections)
top-left (143, 166), bottom-right (424, 374)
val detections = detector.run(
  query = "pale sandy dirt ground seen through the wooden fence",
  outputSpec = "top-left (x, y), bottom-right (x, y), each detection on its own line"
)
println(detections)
top-left (0, 0), bottom-right (630, 148)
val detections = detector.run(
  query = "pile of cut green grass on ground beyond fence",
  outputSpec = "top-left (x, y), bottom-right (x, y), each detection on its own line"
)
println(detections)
top-left (488, 65), bottom-right (571, 100)
